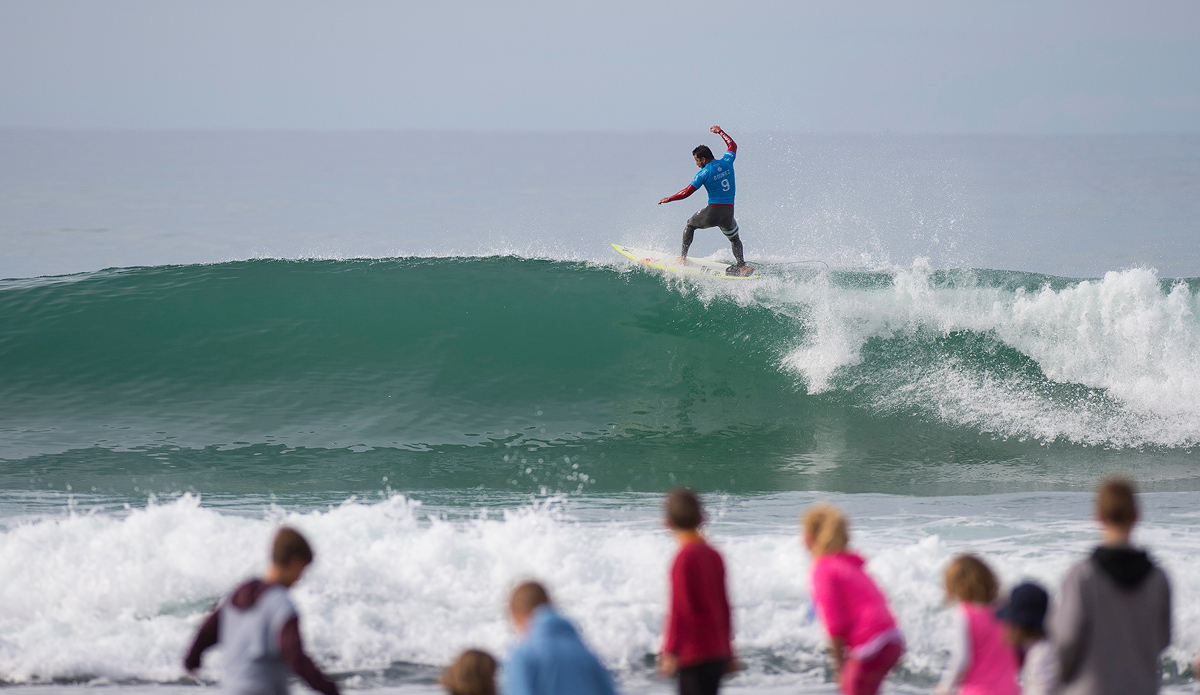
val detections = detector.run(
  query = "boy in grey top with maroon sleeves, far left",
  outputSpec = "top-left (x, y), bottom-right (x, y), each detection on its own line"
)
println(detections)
top-left (184, 527), bottom-right (337, 695)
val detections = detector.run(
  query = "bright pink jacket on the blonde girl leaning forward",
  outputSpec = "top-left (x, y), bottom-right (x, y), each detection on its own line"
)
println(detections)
top-left (812, 552), bottom-right (896, 651)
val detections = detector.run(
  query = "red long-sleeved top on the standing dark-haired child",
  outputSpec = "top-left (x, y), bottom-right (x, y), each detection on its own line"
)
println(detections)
top-left (662, 540), bottom-right (733, 669)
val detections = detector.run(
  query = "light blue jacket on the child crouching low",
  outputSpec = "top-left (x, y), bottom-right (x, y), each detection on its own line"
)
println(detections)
top-left (503, 606), bottom-right (616, 695)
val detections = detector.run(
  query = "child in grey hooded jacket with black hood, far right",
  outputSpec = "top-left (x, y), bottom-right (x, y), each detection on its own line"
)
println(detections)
top-left (1050, 478), bottom-right (1171, 695)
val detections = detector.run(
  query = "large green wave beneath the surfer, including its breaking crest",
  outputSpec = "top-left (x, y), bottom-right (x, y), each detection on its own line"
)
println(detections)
top-left (0, 257), bottom-right (1200, 493)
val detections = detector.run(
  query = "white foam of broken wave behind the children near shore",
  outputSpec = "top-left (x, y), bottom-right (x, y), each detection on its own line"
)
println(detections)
top-left (0, 493), bottom-right (1200, 685)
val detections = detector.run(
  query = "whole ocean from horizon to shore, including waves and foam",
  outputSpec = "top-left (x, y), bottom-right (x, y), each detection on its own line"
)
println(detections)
top-left (0, 131), bottom-right (1200, 695)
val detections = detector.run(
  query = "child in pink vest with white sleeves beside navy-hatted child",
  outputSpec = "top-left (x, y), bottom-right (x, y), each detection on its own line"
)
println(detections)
top-left (934, 555), bottom-right (1021, 695)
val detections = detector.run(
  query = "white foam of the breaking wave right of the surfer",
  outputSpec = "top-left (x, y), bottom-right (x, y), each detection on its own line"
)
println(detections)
top-left (767, 263), bottom-right (1200, 448)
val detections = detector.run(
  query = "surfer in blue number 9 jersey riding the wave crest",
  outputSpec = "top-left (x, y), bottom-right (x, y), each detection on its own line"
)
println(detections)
top-left (659, 126), bottom-right (754, 275)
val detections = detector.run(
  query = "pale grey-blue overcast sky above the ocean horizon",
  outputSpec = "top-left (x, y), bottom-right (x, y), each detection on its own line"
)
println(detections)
top-left (0, 0), bottom-right (1200, 133)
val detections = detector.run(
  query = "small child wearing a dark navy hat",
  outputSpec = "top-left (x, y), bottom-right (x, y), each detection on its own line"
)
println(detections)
top-left (996, 582), bottom-right (1060, 695)
